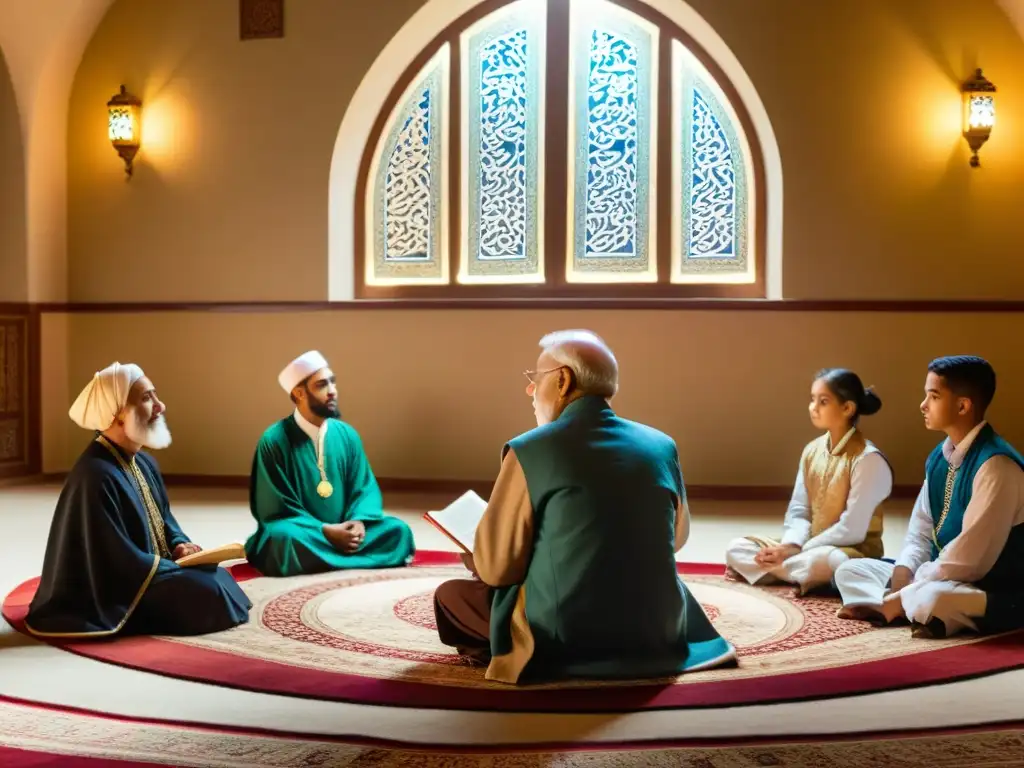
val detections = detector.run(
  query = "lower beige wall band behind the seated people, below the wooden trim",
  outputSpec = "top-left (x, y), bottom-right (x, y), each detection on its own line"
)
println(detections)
top-left (46, 309), bottom-right (1024, 485)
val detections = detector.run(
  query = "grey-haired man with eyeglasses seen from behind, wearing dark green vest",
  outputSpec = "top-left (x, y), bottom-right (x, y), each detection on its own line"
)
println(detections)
top-left (434, 331), bottom-right (736, 683)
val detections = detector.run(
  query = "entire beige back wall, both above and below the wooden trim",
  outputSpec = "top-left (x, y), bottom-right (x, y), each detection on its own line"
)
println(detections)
top-left (46, 0), bottom-right (1024, 484)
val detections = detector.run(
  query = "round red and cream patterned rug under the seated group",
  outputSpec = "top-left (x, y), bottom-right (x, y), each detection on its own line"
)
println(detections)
top-left (3, 552), bottom-right (1024, 712)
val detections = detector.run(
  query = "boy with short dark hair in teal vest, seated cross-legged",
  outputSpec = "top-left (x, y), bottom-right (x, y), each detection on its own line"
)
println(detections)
top-left (836, 355), bottom-right (1024, 637)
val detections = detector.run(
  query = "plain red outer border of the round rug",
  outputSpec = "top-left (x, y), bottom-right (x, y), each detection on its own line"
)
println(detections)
top-left (8, 550), bottom-right (1024, 715)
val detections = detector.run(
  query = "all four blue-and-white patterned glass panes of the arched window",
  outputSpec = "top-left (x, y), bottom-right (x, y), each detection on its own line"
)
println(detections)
top-left (365, 0), bottom-right (755, 292)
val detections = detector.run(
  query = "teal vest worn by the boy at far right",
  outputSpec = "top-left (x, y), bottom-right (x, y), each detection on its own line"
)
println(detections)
top-left (925, 424), bottom-right (1024, 589)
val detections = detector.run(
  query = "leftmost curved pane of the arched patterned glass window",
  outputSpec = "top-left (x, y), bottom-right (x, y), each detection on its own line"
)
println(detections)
top-left (367, 46), bottom-right (449, 285)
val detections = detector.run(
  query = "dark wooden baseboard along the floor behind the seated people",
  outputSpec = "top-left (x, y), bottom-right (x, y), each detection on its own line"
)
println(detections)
top-left (33, 472), bottom-right (921, 501)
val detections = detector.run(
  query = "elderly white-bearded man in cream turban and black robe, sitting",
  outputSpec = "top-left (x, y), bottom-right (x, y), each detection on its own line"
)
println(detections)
top-left (26, 362), bottom-right (252, 638)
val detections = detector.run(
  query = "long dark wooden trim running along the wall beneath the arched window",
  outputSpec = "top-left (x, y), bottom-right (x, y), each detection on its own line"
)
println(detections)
top-left (24, 299), bottom-right (1024, 314)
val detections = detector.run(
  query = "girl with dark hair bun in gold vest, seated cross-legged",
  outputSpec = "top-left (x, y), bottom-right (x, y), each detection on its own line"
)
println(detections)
top-left (725, 368), bottom-right (893, 594)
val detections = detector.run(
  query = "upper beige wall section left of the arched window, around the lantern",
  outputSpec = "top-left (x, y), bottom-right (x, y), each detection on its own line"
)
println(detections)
top-left (69, 0), bottom-right (419, 301)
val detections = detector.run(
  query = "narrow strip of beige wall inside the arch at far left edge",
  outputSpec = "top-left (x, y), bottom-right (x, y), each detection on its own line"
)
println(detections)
top-left (0, 53), bottom-right (29, 301)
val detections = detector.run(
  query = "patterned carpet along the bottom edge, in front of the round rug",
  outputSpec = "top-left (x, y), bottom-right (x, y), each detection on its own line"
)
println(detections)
top-left (0, 700), bottom-right (1024, 768)
